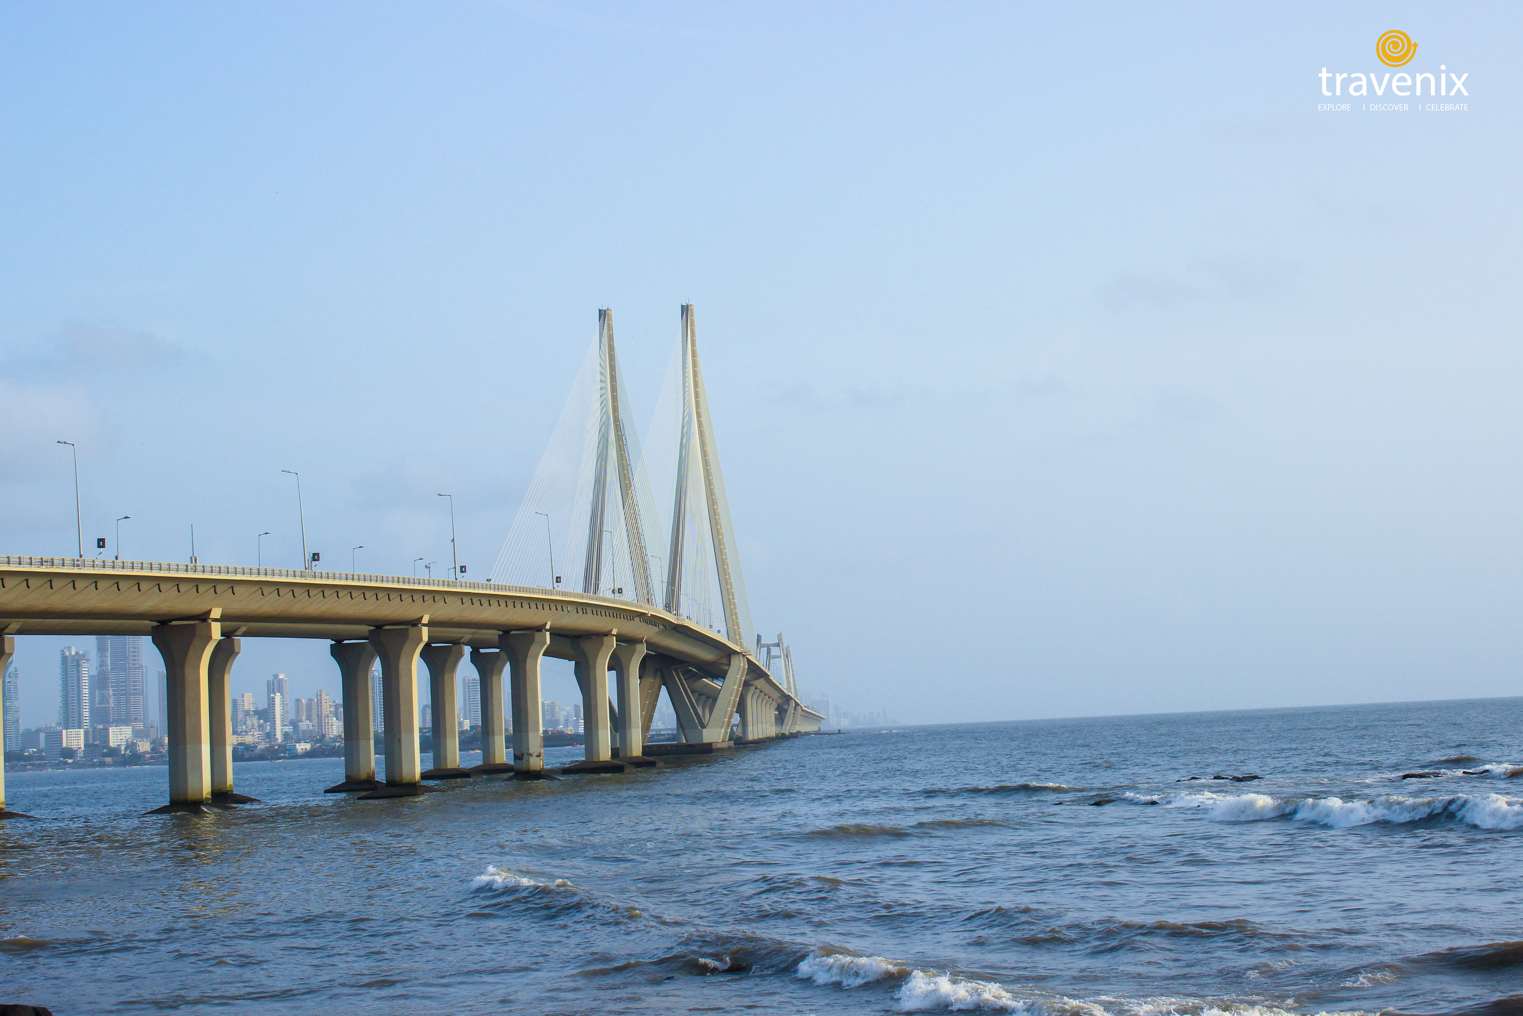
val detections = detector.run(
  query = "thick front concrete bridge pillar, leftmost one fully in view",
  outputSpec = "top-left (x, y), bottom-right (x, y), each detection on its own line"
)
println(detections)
top-left (152, 609), bottom-right (222, 812)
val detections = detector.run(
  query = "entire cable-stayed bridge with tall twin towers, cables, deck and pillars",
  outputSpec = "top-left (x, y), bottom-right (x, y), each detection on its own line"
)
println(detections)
top-left (0, 305), bottom-right (824, 813)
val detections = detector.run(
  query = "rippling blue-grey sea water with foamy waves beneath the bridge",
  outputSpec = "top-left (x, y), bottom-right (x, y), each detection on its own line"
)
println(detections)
top-left (0, 699), bottom-right (1523, 1016)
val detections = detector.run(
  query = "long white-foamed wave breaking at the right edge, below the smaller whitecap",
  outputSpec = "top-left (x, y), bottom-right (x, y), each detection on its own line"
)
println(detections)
top-left (1151, 791), bottom-right (1523, 830)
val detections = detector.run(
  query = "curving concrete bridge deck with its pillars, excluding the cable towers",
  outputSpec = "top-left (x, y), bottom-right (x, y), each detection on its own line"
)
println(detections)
top-left (0, 556), bottom-right (822, 813)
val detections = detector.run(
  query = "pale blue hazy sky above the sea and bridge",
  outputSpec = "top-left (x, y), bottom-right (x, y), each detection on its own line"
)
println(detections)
top-left (0, 2), bottom-right (1523, 725)
